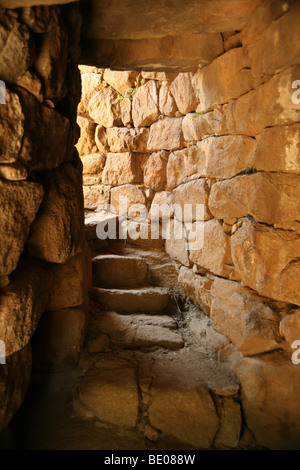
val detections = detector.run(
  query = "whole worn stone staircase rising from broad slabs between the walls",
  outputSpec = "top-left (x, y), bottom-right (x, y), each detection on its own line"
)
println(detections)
top-left (73, 233), bottom-right (241, 449)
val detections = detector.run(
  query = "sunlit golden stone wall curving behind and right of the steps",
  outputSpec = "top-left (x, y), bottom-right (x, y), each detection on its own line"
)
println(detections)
top-left (77, 2), bottom-right (300, 448)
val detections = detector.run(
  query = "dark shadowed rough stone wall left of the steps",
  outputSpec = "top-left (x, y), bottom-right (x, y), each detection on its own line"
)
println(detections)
top-left (0, 5), bottom-right (89, 430)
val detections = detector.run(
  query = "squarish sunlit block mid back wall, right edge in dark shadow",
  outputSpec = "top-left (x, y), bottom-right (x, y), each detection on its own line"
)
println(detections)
top-left (102, 152), bottom-right (143, 185)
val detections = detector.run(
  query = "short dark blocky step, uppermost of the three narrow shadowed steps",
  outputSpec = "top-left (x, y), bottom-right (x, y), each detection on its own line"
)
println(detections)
top-left (93, 254), bottom-right (148, 288)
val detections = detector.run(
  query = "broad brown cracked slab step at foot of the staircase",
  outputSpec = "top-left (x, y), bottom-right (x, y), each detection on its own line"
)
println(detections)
top-left (73, 348), bottom-right (242, 449)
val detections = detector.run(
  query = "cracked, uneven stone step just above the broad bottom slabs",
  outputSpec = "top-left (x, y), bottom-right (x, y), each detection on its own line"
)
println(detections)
top-left (92, 312), bottom-right (184, 350)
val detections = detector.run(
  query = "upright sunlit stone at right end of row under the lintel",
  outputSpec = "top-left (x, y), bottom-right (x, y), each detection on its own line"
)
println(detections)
top-left (170, 72), bottom-right (199, 114)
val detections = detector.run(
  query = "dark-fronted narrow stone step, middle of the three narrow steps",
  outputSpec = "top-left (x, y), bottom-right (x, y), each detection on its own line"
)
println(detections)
top-left (90, 287), bottom-right (170, 313)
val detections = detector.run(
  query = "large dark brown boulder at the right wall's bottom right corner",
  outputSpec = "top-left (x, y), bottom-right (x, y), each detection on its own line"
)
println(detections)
top-left (235, 354), bottom-right (300, 450)
